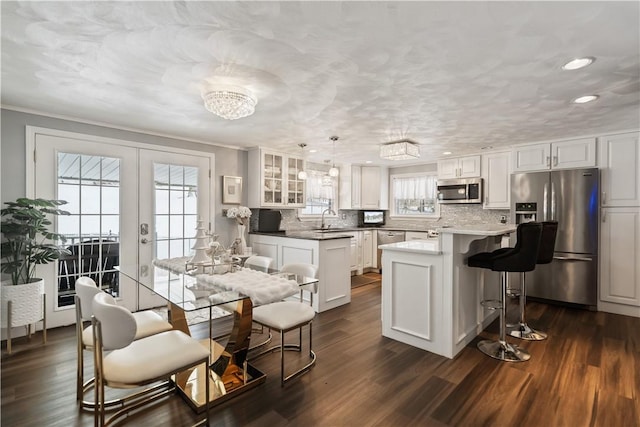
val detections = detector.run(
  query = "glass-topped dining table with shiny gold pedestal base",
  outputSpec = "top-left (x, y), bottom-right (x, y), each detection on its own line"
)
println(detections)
top-left (117, 264), bottom-right (318, 412)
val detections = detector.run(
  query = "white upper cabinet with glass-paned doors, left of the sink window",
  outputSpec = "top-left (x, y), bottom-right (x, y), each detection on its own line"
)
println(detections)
top-left (247, 148), bottom-right (305, 208)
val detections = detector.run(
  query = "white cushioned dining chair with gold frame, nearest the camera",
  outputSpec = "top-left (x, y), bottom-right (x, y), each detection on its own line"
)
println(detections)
top-left (92, 292), bottom-right (210, 426)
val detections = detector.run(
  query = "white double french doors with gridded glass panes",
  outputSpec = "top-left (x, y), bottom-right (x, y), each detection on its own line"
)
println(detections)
top-left (33, 133), bottom-right (212, 327)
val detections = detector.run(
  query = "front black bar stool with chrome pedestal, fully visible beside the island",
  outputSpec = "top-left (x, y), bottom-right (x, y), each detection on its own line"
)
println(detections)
top-left (467, 222), bottom-right (542, 362)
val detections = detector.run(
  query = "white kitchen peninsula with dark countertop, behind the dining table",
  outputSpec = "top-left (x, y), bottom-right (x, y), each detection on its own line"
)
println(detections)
top-left (249, 231), bottom-right (351, 313)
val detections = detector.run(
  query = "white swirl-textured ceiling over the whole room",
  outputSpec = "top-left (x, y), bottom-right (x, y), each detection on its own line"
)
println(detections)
top-left (1, 1), bottom-right (640, 165)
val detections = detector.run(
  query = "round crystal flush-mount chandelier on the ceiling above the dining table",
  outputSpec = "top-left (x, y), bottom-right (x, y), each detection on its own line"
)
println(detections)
top-left (202, 86), bottom-right (258, 120)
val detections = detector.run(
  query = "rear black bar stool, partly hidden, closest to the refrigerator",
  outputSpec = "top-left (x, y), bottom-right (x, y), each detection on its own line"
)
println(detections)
top-left (509, 221), bottom-right (558, 341)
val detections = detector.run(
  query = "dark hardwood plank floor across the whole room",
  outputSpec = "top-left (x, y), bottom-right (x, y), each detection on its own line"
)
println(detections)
top-left (1, 282), bottom-right (640, 427)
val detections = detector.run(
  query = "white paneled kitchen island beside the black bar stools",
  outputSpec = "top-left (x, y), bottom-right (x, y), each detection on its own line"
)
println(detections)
top-left (380, 224), bottom-right (516, 359)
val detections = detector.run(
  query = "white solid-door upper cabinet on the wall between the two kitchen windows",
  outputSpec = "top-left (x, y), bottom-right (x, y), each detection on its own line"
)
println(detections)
top-left (339, 165), bottom-right (389, 209)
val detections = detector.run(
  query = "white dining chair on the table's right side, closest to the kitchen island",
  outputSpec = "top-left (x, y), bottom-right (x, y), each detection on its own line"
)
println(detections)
top-left (253, 264), bottom-right (318, 386)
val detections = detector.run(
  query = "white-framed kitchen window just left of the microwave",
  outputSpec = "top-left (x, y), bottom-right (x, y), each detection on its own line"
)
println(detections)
top-left (391, 172), bottom-right (440, 218)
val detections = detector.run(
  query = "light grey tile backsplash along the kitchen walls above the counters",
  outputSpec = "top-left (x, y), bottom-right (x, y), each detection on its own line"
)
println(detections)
top-left (251, 205), bottom-right (509, 230)
